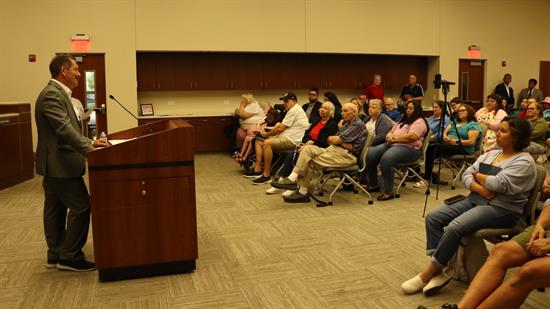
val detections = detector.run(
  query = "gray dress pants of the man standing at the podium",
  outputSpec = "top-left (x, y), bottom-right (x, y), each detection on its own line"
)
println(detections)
top-left (42, 177), bottom-right (90, 261)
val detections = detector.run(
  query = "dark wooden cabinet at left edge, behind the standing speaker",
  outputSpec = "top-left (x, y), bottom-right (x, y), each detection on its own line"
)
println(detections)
top-left (0, 103), bottom-right (34, 190)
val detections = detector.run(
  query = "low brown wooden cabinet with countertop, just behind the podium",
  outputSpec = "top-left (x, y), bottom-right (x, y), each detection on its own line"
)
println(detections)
top-left (138, 116), bottom-right (232, 152)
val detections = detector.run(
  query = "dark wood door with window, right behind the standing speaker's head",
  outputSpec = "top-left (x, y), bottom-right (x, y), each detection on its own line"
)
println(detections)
top-left (69, 54), bottom-right (108, 138)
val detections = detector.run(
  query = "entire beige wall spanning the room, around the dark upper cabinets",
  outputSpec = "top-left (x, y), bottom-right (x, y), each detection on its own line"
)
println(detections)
top-left (0, 0), bottom-right (550, 149)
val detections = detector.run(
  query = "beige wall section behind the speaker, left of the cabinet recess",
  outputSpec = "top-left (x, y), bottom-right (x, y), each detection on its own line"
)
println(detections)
top-left (0, 0), bottom-right (137, 149)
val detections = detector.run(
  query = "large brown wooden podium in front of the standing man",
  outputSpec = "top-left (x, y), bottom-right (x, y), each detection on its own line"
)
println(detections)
top-left (88, 119), bottom-right (198, 281)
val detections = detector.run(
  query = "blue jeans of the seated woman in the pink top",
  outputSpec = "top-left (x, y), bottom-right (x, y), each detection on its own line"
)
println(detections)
top-left (367, 143), bottom-right (420, 194)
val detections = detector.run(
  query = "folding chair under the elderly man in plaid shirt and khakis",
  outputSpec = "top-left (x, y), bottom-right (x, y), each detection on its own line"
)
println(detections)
top-left (311, 136), bottom-right (373, 207)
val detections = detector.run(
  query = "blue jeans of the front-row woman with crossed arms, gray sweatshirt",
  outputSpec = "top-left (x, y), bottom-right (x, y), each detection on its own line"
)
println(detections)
top-left (426, 197), bottom-right (520, 267)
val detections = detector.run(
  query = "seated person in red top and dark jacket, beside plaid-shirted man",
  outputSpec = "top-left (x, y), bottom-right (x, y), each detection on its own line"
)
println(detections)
top-left (266, 101), bottom-right (338, 196)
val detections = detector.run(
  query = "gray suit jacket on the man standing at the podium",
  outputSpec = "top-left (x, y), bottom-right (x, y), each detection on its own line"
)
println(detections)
top-left (35, 80), bottom-right (94, 178)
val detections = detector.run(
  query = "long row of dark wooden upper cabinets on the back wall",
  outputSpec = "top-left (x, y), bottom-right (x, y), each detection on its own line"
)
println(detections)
top-left (137, 52), bottom-right (428, 91)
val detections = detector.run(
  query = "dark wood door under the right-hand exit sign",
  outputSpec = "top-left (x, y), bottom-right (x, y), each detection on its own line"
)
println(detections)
top-left (457, 59), bottom-right (485, 104)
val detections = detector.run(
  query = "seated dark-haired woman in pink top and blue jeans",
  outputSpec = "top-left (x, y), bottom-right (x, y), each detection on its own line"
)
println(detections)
top-left (367, 101), bottom-right (428, 201)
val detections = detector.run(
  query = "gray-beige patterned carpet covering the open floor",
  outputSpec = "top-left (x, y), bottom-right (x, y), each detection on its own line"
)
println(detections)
top-left (0, 154), bottom-right (550, 309)
